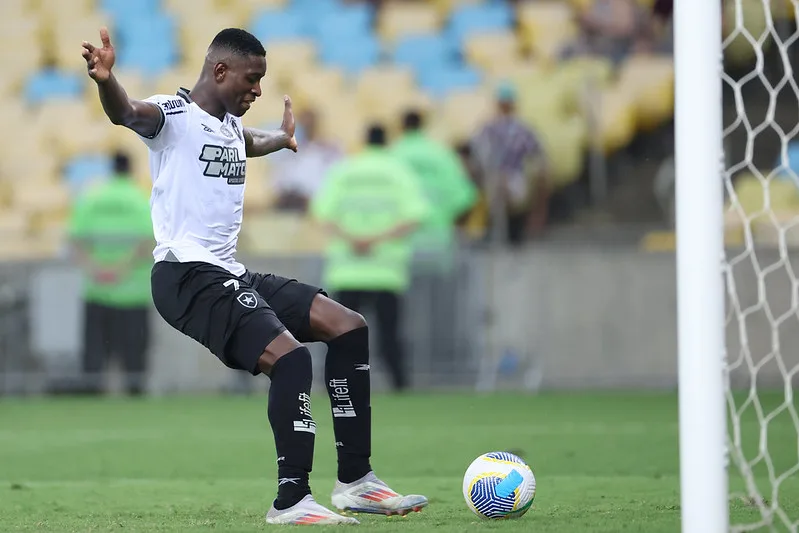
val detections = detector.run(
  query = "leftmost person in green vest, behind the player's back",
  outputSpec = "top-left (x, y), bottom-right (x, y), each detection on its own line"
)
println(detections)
top-left (69, 153), bottom-right (154, 395)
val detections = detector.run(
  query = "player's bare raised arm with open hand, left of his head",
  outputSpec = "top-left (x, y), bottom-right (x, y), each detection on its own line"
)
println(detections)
top-left (83, 28), bottom-right (163, 137)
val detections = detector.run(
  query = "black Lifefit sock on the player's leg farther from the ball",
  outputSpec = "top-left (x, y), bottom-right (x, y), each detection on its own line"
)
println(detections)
top-left (267, 346), bottom-right (316, 509)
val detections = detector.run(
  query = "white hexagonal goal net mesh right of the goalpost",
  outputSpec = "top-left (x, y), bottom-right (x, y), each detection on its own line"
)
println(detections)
top-left (722, 0), bottom-right (799, 532)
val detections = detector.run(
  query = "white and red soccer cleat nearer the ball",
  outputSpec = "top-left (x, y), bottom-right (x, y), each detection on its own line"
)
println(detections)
top-left (331, 472), bottom-right (427, 516)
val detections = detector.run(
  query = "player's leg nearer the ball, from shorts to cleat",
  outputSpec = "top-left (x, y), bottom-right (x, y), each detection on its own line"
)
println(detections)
top-left (250, 274), bottom-right (427, 514)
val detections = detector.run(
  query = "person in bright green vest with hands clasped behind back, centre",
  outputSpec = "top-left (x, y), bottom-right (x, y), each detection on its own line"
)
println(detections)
top-left (311, 126), bottom-right (430, 391)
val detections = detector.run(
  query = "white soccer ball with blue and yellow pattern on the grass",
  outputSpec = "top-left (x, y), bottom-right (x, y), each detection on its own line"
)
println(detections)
top-left (463, 452), bottom-right (535, 518)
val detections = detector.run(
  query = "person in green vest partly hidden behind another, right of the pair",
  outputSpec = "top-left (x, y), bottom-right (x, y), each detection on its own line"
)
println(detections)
top-left (392, 110), bottom-right (478, 372)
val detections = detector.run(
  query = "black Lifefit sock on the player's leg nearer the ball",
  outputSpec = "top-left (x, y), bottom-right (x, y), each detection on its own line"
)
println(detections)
top-left (325, 327), bottom-right (372, 483)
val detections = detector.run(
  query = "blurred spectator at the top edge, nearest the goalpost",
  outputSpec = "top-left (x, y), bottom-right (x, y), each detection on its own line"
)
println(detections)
top-left (563, 0), bottom-right (653, 63)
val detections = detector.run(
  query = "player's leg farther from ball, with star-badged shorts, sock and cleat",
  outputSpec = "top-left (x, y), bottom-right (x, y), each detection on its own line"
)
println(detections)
top-left (152, 263), bottom-right (353, 524)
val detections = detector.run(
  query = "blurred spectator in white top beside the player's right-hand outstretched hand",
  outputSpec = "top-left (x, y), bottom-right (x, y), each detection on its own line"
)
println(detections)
top-left (272, 110), bottom-right (342, 212)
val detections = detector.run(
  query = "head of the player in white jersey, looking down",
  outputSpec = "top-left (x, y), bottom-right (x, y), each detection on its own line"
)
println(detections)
top-left (205, 28), bottom-right (266, 117)
